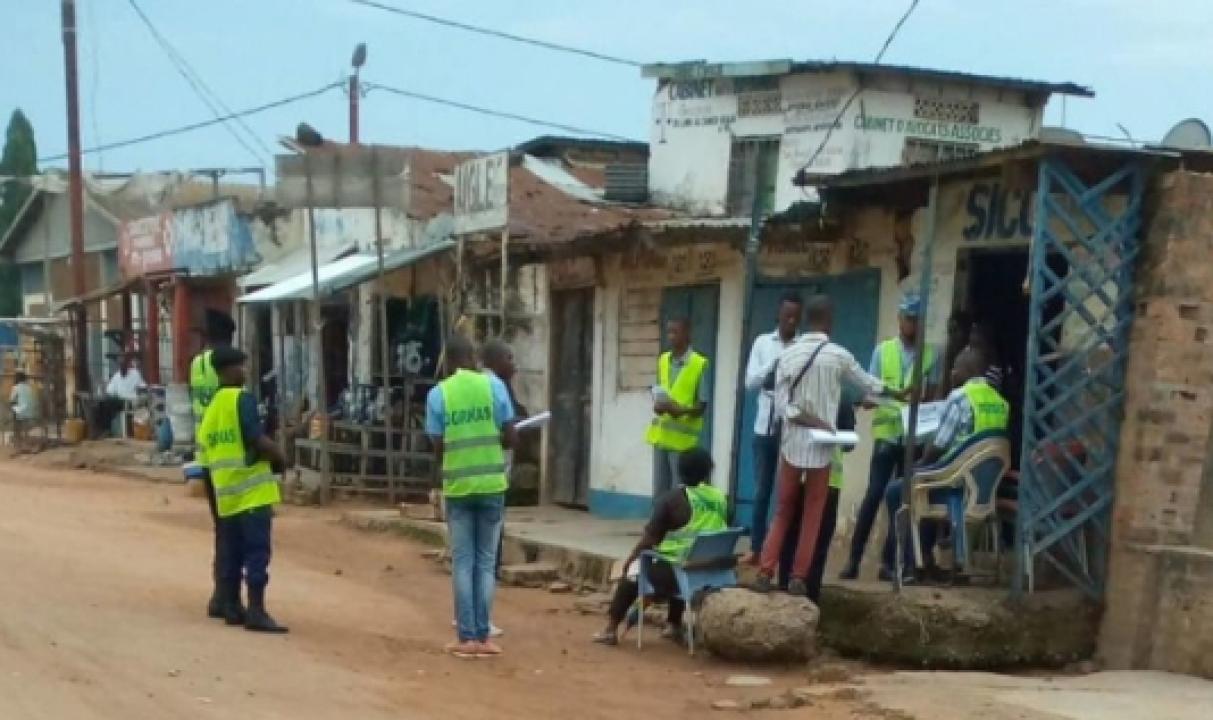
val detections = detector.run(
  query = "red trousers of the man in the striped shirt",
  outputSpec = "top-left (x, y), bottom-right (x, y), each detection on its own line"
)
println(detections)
top-left (761, 457), bottom-right (830, 579)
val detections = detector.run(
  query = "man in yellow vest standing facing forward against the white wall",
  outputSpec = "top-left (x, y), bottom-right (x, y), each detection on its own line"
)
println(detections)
top-left (645, 318), bottom-right (707, 501)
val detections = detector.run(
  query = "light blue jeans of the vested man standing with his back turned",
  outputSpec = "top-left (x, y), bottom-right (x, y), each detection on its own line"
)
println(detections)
top-left (446, 495), bottom-right (506, 642)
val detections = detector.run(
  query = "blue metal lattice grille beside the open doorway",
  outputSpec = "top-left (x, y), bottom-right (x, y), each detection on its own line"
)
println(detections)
top-left (1014, 158), bottom-right (1144, 598)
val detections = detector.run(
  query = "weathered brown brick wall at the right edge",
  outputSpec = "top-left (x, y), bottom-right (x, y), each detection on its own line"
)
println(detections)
top-left (1099, 172), bottom-right (1213, 678)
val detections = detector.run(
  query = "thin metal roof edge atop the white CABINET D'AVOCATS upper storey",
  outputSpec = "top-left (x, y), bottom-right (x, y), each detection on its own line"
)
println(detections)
top-left (643, 58), bottom-right (1095, 97)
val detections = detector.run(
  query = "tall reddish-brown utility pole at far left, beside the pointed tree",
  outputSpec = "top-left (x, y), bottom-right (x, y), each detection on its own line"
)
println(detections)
top-left (61, 0), bottom-right (90, 393)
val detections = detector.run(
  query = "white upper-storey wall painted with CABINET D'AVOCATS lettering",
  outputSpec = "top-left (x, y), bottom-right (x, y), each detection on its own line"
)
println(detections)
top-left (649, 73), bottom-right (1041, 215)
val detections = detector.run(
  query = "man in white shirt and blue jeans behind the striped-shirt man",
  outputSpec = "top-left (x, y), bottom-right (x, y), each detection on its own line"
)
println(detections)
top-left (746, 292), bottom-right (804, 562)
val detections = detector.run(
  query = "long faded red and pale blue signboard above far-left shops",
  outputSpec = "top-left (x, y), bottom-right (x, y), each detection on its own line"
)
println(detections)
top-left (118, 200), bottom-right (260, 278)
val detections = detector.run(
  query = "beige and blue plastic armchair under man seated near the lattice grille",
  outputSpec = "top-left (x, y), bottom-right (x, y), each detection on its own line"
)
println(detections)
top-left (895, 430), bottom-right (1010, 576)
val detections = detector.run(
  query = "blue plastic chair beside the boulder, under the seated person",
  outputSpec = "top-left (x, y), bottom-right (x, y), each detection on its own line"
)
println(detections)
top-left (636, 527), bottom-right (745, 655)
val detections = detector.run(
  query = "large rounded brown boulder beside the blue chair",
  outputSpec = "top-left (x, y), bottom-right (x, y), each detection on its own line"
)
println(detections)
top-left (696, 588), bottom-right (820, 663)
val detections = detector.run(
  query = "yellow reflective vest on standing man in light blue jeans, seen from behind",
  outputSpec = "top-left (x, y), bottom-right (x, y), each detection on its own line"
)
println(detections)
top-left (438, 370), bottom-right (509, 498)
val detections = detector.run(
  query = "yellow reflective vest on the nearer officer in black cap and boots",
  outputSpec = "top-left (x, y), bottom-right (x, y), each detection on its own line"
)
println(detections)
top-left (194, 388), bottom-right (281, 518)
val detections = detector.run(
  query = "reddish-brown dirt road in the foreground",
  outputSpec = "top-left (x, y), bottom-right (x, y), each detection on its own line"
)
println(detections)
top-left (0, 461), bottom-right (863, 720)
